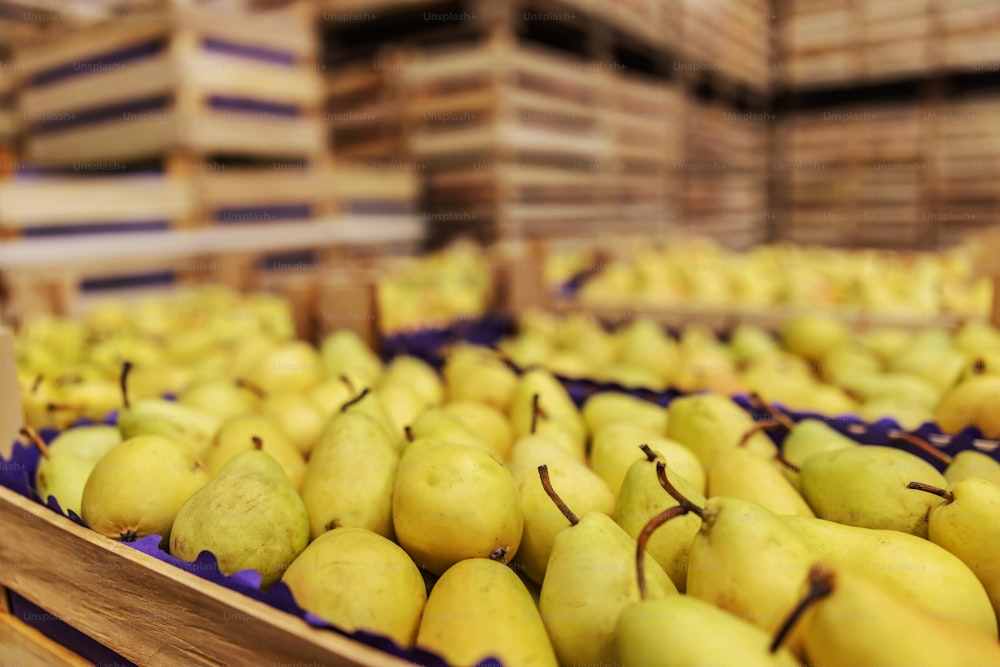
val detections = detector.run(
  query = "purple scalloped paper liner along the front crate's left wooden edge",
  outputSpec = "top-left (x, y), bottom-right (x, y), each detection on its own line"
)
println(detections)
top-left (0, 430), bottom-right (500, 667)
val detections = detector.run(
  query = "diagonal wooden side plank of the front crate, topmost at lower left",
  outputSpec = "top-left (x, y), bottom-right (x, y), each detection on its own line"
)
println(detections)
top-left (0, 489), bottom-right (409, 667)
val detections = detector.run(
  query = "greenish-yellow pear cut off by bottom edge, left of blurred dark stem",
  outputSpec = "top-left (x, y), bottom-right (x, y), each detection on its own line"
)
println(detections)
top-left (615, 595), bottom-right (799, 667)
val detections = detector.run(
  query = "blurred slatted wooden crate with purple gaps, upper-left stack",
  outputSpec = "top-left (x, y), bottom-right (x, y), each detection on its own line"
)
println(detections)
top-left (15, 6), bottom-right (323, 165)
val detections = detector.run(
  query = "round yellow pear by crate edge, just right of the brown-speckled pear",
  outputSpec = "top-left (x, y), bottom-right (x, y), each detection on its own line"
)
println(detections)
top-left (281, 528), bottom-right (427, 647)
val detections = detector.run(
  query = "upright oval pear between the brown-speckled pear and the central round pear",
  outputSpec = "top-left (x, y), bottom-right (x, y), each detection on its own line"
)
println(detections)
top-left (302, 412), bottom-right (399, 539)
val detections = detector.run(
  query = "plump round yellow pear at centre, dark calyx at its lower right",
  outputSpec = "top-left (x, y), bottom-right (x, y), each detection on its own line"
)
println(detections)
top-left (392, 441), bottom-right (524, 574)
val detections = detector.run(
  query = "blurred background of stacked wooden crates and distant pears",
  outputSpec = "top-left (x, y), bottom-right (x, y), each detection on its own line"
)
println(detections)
top-left (0, 0), bottom-right (1000, 333)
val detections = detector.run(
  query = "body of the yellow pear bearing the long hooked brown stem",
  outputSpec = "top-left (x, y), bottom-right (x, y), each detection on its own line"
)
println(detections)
top-left (687, 497), bottom-right (814, 633)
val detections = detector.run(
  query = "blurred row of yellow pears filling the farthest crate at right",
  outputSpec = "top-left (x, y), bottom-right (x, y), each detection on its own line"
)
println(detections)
top-left (545, 237), bottom-right (993, 316)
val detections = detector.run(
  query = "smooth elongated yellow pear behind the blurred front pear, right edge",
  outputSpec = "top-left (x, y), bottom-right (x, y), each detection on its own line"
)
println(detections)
top-left (781, 516), bottom-right (997, 637)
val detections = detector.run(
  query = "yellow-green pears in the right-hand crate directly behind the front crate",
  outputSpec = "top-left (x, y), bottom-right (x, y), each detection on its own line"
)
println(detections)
top-left (499, 311), bottom-right (1000, 438)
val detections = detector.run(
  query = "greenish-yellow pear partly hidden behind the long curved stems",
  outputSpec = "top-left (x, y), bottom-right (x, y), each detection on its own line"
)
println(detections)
top-left (611, 445), bottom-right (705, 593)
